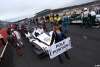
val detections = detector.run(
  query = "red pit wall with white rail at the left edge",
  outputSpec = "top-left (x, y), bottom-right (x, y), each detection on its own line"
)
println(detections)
top-left (0, 28), bottom-right (8, 59)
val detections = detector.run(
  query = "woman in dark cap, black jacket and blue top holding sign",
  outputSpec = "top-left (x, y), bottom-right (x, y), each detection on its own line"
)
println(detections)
top-left (50, 22), bottom-right (70, 63)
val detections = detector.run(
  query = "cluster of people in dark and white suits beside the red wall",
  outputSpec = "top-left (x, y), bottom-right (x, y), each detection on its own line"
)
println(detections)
top-left (7, 22), bottom-right (27, 56)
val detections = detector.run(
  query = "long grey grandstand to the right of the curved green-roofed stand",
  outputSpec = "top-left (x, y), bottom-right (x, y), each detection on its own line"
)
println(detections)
top-left (52, 0), bottom-right (100, 13)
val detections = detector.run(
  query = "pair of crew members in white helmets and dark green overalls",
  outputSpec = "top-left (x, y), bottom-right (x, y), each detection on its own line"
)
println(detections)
top-left (81, 8), bottom-right (96, 28)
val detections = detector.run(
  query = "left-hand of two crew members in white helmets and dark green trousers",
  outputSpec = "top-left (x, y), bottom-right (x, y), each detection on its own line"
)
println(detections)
top-left (81, 8), bottom-right (89, 28)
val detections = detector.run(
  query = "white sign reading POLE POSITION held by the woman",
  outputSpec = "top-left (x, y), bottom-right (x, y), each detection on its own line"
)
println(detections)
top-left (49, 37), bottom-right (71, 59)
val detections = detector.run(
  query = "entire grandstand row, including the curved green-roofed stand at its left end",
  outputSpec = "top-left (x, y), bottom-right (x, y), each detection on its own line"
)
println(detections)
top-left (35, 0), bottom-right (100, 17)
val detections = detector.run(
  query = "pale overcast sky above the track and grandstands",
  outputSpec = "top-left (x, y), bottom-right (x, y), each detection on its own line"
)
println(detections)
top-left (0, 0), bottom-right (93, 22)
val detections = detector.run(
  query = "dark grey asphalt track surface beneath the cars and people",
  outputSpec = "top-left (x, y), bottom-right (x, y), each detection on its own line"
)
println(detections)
top-left (0, 23), bottom-right (100, 67)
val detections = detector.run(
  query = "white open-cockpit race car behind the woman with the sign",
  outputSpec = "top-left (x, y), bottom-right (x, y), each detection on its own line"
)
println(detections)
top-left (25, 28), bottom-right (53, 57)
